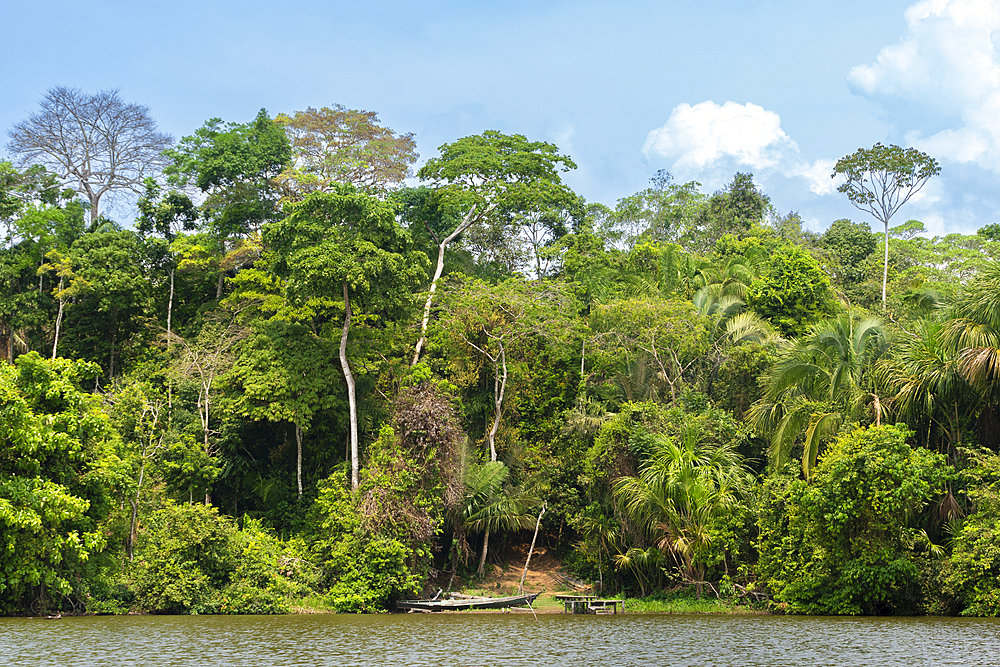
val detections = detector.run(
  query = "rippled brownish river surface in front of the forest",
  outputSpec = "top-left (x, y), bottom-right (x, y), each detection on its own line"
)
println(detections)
top-left (0, 613), bottom-right (1000, 667)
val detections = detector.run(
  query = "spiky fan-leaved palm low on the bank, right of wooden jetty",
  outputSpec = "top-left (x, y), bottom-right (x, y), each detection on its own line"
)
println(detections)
top-left (614, 426), bottom-right (750, 594)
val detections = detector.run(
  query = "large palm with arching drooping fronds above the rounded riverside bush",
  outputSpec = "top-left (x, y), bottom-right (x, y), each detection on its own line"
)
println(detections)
top-left (747, 310), bottom-right (888, 478)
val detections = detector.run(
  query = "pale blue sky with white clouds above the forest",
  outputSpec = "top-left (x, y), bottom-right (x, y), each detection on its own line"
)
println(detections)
top-left (0, 0), bottom-right (1000, 235)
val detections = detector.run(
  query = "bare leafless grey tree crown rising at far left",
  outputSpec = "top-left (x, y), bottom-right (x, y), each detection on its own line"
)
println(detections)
top-left (7, 86), bottom-right (173, 223)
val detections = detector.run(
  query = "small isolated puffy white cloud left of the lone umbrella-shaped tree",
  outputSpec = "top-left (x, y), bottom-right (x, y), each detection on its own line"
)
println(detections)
top-left (642, 100), bottom-right (836, 195)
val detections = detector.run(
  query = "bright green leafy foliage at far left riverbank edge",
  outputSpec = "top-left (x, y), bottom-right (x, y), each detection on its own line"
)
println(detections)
top-left (0, 352), bottom-right (121, 612)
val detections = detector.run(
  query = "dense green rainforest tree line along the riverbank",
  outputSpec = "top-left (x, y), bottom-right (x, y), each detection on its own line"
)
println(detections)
top-left (0, 88), bottom-right (1000, 615)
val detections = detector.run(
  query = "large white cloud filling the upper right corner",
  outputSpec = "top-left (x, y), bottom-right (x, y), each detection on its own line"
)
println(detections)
top-left (848, 0), bottom-right (1000, 172)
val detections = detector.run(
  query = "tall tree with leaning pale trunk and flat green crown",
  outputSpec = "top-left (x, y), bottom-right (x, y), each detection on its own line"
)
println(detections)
top-left (413, 130), bottom-right (576, 365)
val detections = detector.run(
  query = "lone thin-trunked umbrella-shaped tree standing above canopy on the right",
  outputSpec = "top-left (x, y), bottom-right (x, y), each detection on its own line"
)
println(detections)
top-left (831, 143), bottom-right (941, 310)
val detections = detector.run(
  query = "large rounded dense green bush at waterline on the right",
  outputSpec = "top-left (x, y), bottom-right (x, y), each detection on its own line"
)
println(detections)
top-left (758, 426), bottom-right (951, 614)
